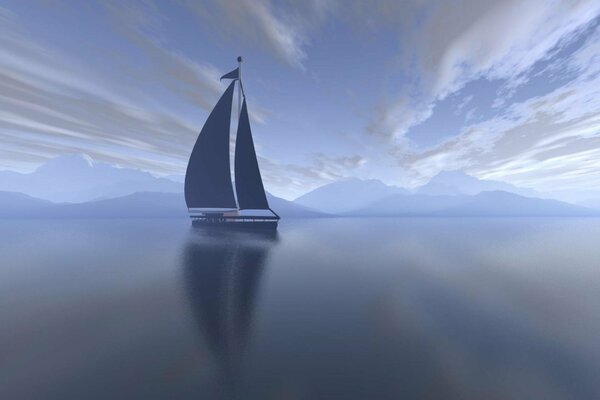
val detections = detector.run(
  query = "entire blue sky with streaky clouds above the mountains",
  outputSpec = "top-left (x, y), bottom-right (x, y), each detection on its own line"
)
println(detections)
top-left (0, 0), bottom-right (600, 199)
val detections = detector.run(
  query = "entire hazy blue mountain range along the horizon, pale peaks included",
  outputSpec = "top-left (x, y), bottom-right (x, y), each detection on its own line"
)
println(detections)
top-left (0, 155), bottom-right (600, 218)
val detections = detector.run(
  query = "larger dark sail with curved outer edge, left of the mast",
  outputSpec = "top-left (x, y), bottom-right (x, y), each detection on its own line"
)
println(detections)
top-left (185, 81), bottom-right (237, 208)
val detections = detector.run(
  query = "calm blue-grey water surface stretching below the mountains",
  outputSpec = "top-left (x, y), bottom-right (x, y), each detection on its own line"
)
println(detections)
top-left (0, 219), bottom-right (600, 400)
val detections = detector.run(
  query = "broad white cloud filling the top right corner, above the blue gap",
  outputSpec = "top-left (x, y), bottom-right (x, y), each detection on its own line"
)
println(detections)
top-left (367, 0), bottom-right (600, 139)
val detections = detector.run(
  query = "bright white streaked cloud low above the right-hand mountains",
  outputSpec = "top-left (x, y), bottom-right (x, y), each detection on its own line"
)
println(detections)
top-left (395, 20), bottom-right (600, 192)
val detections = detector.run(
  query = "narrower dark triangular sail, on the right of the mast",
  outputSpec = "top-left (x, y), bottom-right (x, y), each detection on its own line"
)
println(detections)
top-left (235, 99), bottom-right (269, 210)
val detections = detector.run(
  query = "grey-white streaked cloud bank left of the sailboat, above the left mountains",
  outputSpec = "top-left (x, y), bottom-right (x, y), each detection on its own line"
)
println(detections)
top-left (0, 8), bottom-right (204, 173)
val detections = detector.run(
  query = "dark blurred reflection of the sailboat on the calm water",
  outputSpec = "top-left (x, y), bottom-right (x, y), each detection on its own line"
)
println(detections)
top-left (184, 228), bottom-right (278, 399)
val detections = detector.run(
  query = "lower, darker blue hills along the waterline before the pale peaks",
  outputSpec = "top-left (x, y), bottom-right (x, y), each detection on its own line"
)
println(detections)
top-left (0, 191), bottom-right (600, 219)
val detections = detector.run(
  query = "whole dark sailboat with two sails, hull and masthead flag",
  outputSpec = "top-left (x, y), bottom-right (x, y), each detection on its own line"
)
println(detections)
top-left (185, 57), bottom-right (280, 229)
